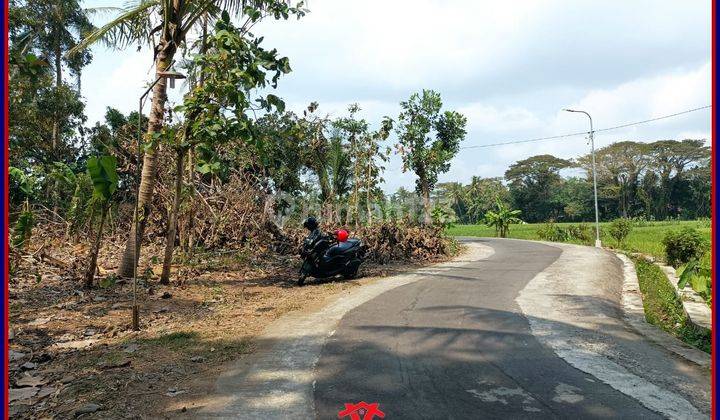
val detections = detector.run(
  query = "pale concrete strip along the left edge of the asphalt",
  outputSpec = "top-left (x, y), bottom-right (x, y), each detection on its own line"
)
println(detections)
top-left (197, 242), bottom-right (494, 419)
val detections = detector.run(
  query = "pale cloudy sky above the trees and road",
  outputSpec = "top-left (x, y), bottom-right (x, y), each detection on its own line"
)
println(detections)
top-left (83, 0), bottom-right (711, 191)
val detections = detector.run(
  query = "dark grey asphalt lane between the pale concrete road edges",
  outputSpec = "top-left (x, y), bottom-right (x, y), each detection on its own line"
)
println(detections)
top-left (314, 240), bottom-right (704, 419)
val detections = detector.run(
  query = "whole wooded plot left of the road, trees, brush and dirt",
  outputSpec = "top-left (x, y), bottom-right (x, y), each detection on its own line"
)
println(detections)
top-left (9, 0), bottom-right (466, 419)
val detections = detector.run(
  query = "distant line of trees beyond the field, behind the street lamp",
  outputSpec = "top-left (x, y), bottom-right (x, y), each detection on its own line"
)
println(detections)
top-left (416, 139), bottom-right (711, 223)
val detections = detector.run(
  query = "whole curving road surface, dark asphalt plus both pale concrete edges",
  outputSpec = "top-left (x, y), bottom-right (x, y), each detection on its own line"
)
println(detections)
top-left (200, 239), bottom-right (710, 419)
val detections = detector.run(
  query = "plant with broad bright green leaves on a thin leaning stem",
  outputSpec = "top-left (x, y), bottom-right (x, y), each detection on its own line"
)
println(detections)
top-left (85, 156), bottom-right (118, 287)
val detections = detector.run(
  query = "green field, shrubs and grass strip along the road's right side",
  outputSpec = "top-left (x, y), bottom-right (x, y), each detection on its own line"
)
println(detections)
top-left (448, 219), bottom-right (712, 352)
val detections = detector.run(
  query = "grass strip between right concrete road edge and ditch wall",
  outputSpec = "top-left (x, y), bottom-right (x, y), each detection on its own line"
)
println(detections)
top-left (633, 258), bottom-right (711, 353)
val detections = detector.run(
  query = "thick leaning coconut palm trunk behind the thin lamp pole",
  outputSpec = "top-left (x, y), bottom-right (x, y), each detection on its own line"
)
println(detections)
top-left (118, 44), bottom-right (176, 277)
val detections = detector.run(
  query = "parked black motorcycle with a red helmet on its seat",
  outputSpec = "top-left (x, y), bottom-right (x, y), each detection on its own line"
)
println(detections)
top-left (298, 217), bottom-right (365, 286)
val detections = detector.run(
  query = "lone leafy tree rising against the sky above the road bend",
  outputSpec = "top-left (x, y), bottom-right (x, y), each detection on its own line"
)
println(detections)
top-left (397, 90), bottom-right (467, 224)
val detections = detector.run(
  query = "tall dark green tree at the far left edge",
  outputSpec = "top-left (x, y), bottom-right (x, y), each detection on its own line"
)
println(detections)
top-left (9, 0), bottom-right (92, 215)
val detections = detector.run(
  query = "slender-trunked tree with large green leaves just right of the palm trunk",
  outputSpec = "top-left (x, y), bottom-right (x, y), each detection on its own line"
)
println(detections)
top-left (160, 12), bottom-right (290, 284)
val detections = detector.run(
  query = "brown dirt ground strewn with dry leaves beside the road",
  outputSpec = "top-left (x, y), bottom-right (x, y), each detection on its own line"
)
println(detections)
top-left (10, 235), bottom-right (444, 419)
